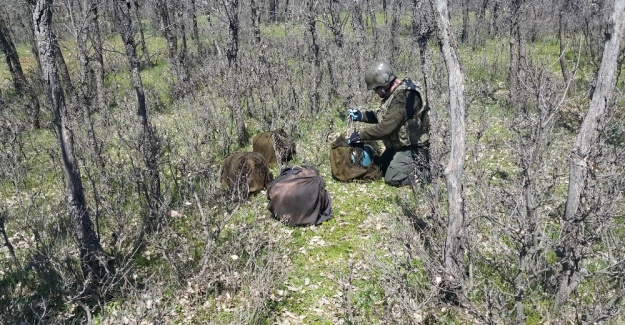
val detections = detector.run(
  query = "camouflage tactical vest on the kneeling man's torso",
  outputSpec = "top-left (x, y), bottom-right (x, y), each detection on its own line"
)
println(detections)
top-left (376, 78), bottom-right (429, 148)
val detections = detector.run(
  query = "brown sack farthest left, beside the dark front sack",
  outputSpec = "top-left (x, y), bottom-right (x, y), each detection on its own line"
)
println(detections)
top-left (221, 152), bottom-right (273, 200)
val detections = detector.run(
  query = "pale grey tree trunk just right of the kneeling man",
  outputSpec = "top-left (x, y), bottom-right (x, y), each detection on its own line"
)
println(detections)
top-left (435, 0), bottom-right (466, 293)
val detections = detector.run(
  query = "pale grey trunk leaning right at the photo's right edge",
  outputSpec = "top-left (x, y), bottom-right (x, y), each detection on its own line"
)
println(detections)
top-left (554, 0), bottom-right (625, 308)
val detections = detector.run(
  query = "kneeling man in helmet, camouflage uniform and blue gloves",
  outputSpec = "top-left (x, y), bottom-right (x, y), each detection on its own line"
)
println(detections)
top-left (348, 61), bottom-right (430, 186)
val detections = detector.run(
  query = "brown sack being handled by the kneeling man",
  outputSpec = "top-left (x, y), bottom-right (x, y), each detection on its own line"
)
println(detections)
top-left (330, 134), bottom-right (382, 182)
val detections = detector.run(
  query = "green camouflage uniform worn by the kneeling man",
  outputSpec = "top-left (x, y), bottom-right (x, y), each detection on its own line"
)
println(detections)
top-left (360, 79), bottom-right (430, 186)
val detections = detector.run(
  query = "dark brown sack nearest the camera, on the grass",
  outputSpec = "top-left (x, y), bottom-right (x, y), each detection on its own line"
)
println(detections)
top-left (267, 166), bottom-right (332, 226)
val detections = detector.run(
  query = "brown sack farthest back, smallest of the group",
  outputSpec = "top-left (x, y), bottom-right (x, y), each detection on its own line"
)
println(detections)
top-left (252, 129), bottom-right (295, 166)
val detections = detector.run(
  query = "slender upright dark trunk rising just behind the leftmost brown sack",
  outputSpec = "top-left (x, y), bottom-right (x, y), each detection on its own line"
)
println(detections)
top-left (224, 0), bottom-right (249, 147)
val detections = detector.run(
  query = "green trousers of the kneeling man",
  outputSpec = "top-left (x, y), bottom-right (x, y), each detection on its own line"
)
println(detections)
top-left (380, 145), bottom-right (431, 186)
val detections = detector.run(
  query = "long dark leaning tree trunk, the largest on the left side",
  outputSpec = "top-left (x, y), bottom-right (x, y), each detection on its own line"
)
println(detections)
top-left (33, 0), bottom-right (105, 280)
